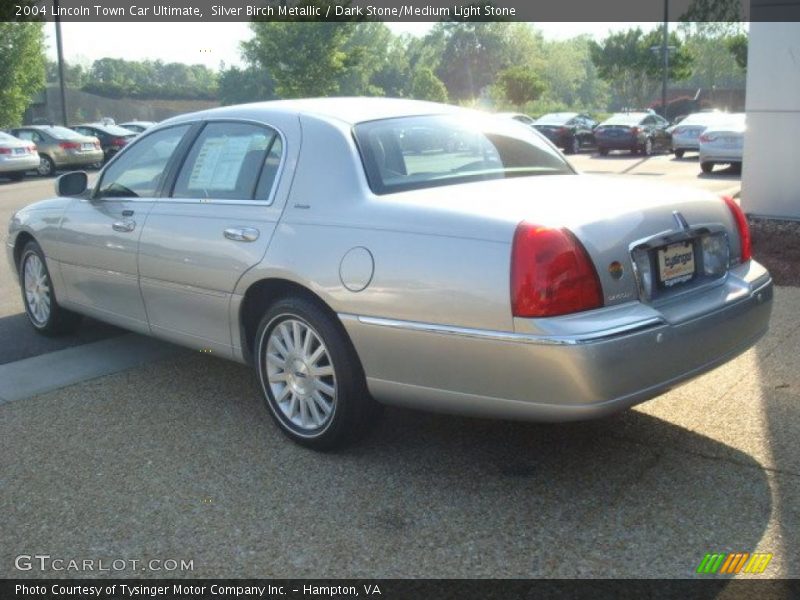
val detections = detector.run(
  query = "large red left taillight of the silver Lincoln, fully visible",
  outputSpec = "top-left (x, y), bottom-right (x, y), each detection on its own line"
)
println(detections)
top-left (511, 221), bottom-right (603, 317)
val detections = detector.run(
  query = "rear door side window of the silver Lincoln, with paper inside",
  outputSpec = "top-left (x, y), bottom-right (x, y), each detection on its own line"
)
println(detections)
top-left (172, 123), bottom-right (283, 201)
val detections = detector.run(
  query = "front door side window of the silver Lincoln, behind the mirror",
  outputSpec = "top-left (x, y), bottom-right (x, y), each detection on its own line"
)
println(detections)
top-left (97, 125), bottom-right (189, 198)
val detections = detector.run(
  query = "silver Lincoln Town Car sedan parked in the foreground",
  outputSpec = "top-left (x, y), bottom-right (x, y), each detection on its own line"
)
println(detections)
top-left (8, 98), bottom-right (772, 449)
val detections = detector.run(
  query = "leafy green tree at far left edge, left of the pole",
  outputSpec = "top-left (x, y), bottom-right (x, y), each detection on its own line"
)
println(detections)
top-left (0, 22), bottom-right (45, 127)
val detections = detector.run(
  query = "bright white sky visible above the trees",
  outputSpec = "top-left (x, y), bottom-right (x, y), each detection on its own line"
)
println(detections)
top-left (46, 22), bottom-right (655, 69)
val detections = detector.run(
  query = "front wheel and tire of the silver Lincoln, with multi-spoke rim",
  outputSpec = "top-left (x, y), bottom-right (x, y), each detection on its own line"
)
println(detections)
top-left (19, 241), bottom-right (81, 337)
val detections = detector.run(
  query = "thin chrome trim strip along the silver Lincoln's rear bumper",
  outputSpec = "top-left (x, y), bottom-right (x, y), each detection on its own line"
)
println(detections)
top-left (339, 313), bottom-right (664, 346)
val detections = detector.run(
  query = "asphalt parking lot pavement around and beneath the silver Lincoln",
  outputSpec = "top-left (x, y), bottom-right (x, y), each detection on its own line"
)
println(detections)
top-left (0, 155), bottom-right (800, 578)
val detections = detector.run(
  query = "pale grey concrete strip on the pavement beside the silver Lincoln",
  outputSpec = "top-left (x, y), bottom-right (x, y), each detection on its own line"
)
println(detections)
top-left (0, 333), bottom-right (184, 404)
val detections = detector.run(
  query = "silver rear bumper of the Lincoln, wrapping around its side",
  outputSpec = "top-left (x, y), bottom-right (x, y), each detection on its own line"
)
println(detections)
top-left (340, 265), bottom-right (772, 421)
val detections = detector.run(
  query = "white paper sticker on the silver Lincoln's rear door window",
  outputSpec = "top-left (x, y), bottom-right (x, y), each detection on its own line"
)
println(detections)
top-left (189, 136), bottom-right (251, 191)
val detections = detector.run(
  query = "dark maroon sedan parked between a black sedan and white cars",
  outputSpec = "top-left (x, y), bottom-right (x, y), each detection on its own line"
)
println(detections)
top-left (594, 112), bottom-right (672, 156)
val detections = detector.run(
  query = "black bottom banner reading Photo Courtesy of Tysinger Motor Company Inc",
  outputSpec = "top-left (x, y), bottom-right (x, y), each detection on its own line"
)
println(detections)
top-left (0, 579), bottom-right (800, 600)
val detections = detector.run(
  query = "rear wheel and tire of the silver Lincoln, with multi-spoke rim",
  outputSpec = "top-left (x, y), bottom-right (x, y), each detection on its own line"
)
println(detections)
top-left (255, 297), bottom-right (380, 450)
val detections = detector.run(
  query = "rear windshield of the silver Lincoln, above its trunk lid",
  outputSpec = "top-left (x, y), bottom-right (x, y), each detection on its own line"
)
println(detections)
top-left (354, 115), bottom-right (573, 194)
